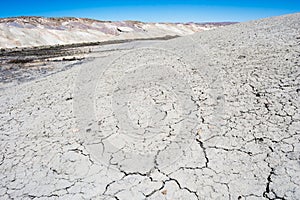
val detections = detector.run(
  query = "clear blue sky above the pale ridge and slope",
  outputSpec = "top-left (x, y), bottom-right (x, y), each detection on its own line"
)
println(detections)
top-left (0, 0), bottom-right (300, 22)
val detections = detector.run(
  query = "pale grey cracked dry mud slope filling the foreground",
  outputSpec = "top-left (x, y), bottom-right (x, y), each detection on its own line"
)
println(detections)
top-left (0, 14), bottom-right (300, 200)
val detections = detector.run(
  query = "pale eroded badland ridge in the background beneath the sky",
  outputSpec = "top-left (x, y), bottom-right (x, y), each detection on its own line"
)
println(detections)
top-left (0, 17), bottom-right (232, 48)
